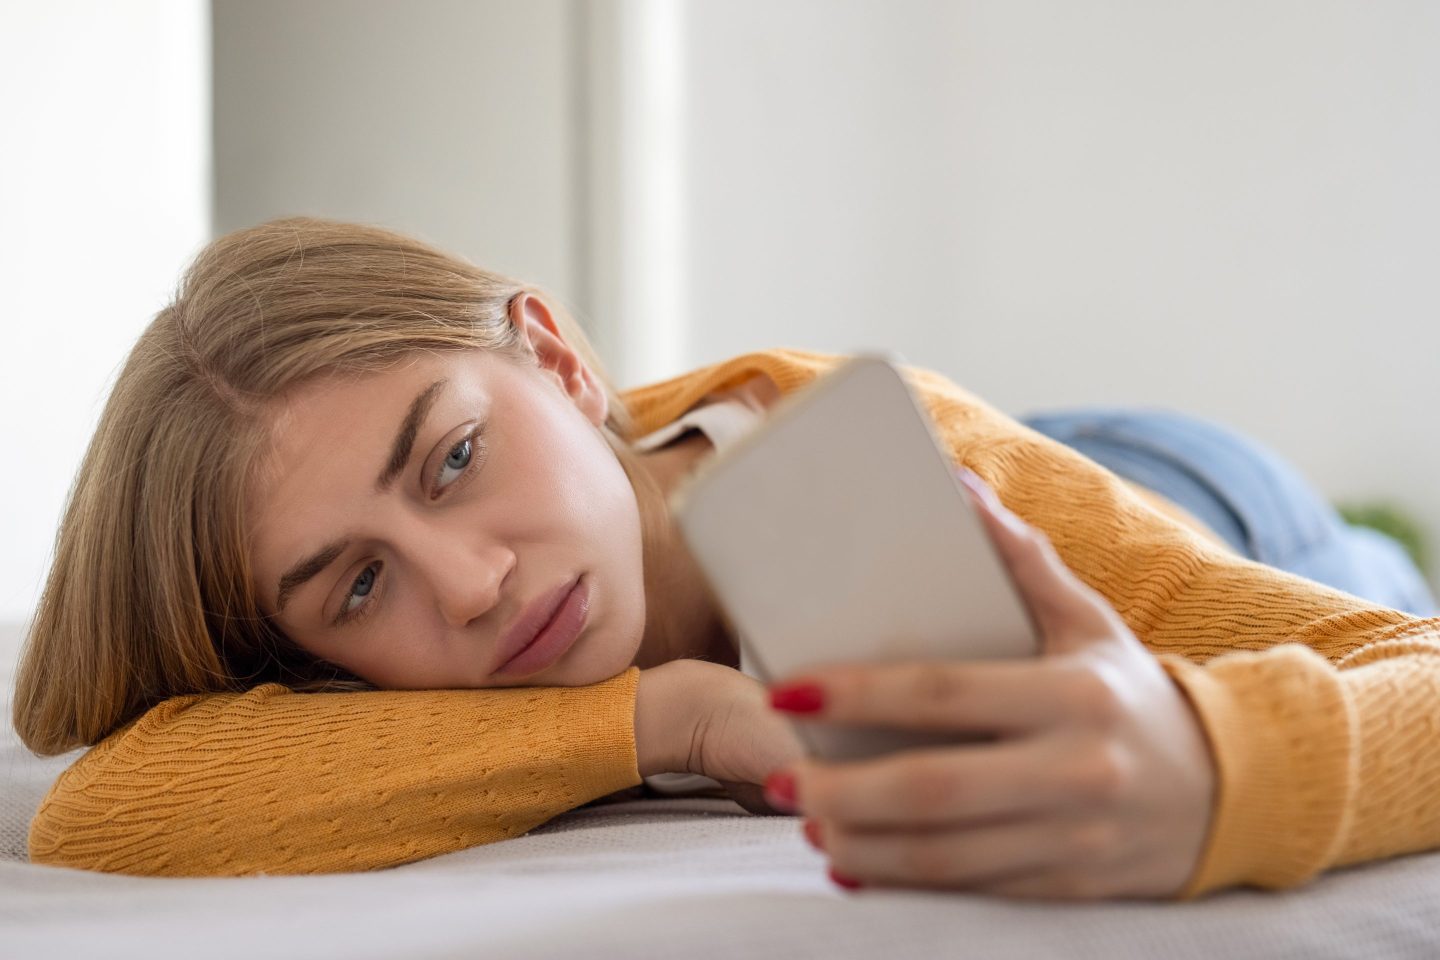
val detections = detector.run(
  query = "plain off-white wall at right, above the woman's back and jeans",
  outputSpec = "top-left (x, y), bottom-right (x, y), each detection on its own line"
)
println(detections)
top-left (665, 0), bottom-right (1440, 586)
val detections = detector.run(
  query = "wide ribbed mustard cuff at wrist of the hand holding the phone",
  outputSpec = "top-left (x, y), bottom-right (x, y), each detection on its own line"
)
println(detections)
top-left (1156, 643), bottom-right (1358, 900)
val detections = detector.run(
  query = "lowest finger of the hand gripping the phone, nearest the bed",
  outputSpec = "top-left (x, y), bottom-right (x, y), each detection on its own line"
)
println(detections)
top-left (818, 818), bottom-right (1116, 889)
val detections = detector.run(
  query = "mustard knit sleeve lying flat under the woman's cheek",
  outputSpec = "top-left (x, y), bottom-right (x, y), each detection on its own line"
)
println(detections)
top-left (29, 666), bottom-right (641, 877)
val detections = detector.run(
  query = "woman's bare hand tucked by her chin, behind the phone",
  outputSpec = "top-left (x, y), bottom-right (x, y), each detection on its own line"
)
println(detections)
top-left (635, 661), bottom-right (805, 813)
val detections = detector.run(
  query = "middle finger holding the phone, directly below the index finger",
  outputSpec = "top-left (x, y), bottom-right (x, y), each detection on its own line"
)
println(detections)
top-left (791, 738), bottom-right (1109, 829)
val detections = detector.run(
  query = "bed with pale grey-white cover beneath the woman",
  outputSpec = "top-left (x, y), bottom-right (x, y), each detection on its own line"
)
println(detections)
top-left (0, 625), bottom-right (1440, 960)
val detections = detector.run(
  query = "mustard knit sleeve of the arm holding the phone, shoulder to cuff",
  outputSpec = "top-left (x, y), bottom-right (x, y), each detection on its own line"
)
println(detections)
top-left (910, 359), bottom-right (1440, 900)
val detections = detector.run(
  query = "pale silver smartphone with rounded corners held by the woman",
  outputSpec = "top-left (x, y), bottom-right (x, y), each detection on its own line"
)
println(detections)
top-left (668, 353), bottom-right (1041, 760)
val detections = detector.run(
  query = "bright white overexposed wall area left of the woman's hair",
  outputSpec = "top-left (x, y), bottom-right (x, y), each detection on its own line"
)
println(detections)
top-left (0, 0), bottom-right (210, 620)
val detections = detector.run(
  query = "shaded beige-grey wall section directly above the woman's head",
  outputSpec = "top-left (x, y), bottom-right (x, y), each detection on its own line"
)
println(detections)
top-left (215, 0), bottom-right (583, 319)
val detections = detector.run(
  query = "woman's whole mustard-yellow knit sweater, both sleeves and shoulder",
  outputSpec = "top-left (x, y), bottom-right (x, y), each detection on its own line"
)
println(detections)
top-left (30, 350), bottom-right (1440, 900)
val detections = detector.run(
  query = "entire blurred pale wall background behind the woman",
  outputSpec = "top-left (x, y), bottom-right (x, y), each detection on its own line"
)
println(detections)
top-left (0, 0), bottom-right (1440, 620)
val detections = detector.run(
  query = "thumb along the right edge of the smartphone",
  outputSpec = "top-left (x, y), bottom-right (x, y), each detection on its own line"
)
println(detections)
top-left (956, 468), bottom-right (1109, 636)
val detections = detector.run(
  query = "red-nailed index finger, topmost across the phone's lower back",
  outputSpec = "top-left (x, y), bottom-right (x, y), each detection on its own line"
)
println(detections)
top-left (770, 658), bottom-right (1084, 735)
